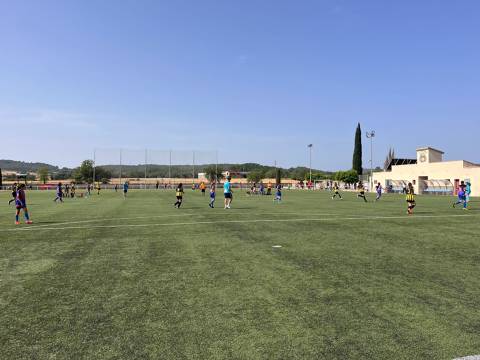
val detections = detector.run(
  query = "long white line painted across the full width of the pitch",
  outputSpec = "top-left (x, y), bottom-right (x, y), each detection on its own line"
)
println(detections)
top-left (5, 215), bottom-right (476, 232)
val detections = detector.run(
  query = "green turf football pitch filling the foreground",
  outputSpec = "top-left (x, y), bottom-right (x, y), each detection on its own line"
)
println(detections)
top-left (0, 190), bottom-right (480, 359)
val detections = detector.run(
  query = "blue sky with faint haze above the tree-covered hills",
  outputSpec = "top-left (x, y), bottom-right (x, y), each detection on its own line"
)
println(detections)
top-left (0, 0), bottom-right (480, 170)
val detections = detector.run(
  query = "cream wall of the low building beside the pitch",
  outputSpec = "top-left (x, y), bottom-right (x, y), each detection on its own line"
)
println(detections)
top-left (373, 161), bottom-right (480, 196)
